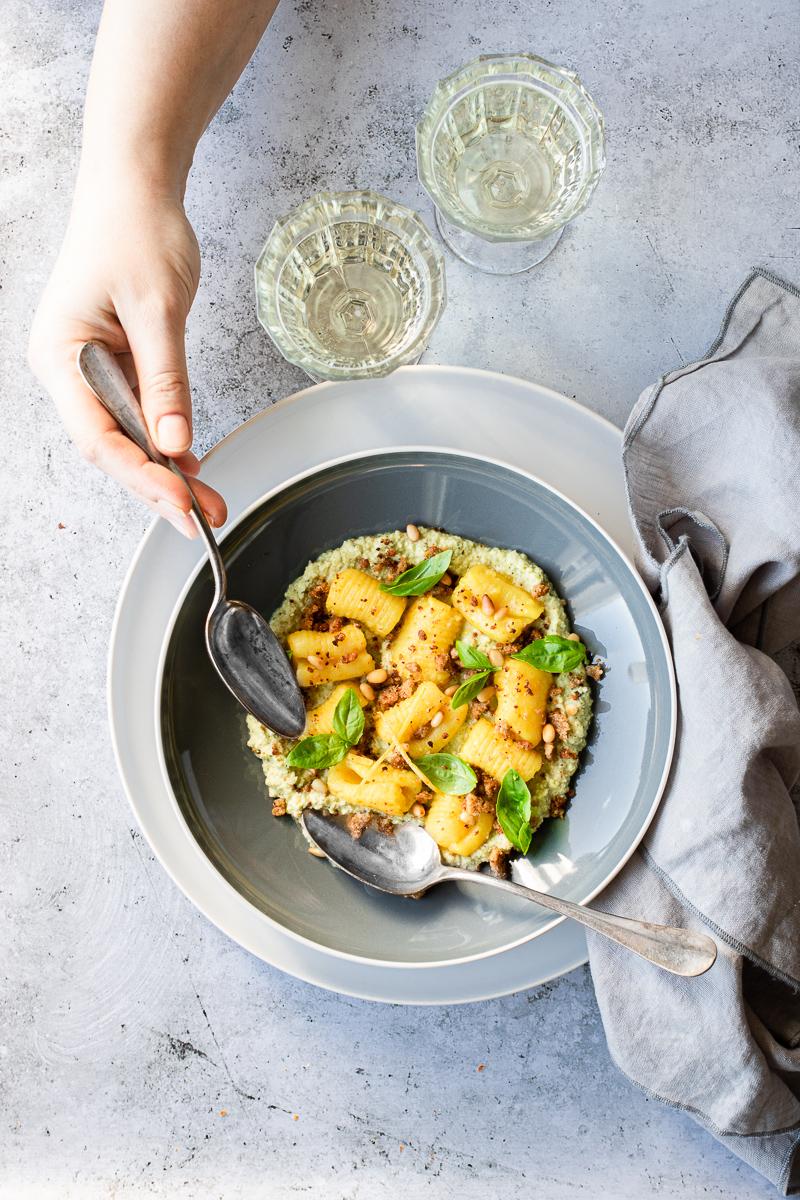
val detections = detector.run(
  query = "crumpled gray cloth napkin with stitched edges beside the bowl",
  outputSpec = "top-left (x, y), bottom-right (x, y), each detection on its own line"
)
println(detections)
top-left (589, 270), bottom-right (800, 1195)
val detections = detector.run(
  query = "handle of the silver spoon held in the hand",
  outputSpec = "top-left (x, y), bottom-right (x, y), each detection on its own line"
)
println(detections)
top-left (78, 342), bottom-right (227, 604)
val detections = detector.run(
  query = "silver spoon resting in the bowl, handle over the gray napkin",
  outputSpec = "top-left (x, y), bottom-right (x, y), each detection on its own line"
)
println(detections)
top-left (302, 809), bottom-right (717, 976)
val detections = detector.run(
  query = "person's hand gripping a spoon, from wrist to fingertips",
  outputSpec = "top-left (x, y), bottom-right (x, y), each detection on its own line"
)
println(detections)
top-left (29, 184), bottom-right (227, 538)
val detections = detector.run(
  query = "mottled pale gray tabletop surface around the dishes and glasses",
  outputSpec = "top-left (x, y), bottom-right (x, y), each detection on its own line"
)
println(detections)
top-left (0, 0), bottom-right (800, 1200)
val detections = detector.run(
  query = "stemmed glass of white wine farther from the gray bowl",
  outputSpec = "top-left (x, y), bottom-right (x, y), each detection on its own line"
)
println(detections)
top-left (416, 54), bottom-right (606, 275)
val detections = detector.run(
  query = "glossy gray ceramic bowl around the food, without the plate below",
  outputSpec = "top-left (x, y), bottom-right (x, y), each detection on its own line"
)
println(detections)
top-left (157, 449), bottom-right (675, 967)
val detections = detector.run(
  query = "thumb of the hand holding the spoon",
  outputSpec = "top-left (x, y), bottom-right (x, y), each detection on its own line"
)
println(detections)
top-left (126, 307), bottom-right (192, 455)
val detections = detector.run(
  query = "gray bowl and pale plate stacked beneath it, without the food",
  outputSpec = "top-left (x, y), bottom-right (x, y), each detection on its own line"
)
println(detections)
top-left (109, 367), bottom-right (675, 1003)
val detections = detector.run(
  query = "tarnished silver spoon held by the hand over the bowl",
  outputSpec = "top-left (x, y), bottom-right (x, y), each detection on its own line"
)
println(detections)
top-left (78, 342), bottom-right (306, 738)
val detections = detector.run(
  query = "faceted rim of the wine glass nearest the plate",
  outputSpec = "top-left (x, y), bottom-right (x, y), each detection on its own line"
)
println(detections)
top-left (253, 187), bottom-right (447, 383)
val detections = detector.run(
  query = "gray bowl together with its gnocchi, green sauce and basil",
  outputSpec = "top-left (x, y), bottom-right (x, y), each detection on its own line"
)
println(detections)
top-left (157, 448), bottom-right (675, 967)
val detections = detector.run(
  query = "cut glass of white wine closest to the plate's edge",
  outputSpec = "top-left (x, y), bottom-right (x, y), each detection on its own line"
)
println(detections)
top-left (255, 191), bottom-right (445, 380)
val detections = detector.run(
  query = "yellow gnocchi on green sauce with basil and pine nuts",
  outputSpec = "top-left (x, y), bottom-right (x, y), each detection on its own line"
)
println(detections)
top-left (247, 524), bottom-right (591, 868)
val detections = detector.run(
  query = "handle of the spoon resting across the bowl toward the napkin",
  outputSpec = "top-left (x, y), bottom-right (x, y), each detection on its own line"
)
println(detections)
top-left (440, 866), bottom-right (717, 976)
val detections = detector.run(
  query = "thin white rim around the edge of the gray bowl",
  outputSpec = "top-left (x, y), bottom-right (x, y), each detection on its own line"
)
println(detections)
top-left (149, 446), bottom-right (678, 971)
